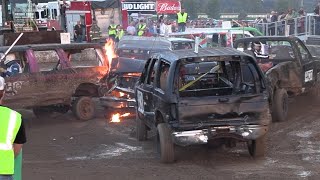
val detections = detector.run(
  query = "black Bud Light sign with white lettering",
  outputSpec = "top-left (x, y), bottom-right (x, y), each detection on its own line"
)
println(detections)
top-left (122, 2), bottom-right (156, 12)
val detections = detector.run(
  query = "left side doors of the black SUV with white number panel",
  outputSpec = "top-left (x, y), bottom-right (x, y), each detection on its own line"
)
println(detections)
top-left (136, 58), bottom-right (157, 126)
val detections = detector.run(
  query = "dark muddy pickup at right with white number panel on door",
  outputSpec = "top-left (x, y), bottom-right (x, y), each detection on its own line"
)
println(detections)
top-left (234, 36), bottom-right (320, 121)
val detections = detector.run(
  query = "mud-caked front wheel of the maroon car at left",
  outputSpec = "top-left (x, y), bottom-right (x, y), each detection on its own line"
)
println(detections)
top-left (72, 97), bottom-right (95, 121)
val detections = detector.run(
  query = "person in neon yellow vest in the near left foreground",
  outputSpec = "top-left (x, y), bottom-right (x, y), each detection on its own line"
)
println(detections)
top-left (0, 77), bottom-right (27, 180)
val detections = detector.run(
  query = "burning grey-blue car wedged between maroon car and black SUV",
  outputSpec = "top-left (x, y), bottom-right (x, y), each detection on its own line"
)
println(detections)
top-left (100, 36), bottom-right (194, 121)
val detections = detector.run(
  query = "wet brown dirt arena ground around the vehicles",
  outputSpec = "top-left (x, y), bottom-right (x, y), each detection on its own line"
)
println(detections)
top-left (23, 97), bottom-right (320, 180)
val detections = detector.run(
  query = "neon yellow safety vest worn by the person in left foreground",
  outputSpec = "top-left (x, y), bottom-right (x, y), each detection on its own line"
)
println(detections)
top-left (0, 106), bottom-right (22, 175)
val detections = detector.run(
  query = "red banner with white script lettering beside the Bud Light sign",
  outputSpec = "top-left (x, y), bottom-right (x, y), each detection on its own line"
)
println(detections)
top-left (157, 0), bottom-right (181, 14)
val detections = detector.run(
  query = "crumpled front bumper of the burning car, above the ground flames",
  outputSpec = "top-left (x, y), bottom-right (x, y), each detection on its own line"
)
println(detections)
top-left (100, 96), bottom-right (136, 109)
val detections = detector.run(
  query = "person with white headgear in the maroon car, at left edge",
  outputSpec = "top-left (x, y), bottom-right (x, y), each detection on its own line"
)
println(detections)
top-left (0, 53), bottom-right (22, 77)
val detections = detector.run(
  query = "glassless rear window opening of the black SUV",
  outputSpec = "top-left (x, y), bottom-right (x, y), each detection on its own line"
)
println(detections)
top-left (175, 57), bottom-right (261, 97)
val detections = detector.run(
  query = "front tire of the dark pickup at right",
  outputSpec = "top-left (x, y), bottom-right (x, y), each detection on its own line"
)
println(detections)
top-left (272, 89), bottom-right (289, 122)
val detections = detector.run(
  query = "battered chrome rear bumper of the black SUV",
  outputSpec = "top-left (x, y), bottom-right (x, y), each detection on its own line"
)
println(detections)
top-left (172, 125), bottom-right (268, 146)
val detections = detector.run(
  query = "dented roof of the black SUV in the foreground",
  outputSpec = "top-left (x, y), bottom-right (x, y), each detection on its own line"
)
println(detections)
top-left (153, 47), bottom-right (250, 62)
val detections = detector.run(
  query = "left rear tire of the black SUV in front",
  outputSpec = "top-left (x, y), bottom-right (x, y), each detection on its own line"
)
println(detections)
top-left (157, 123), bottom-right (175, 163)
